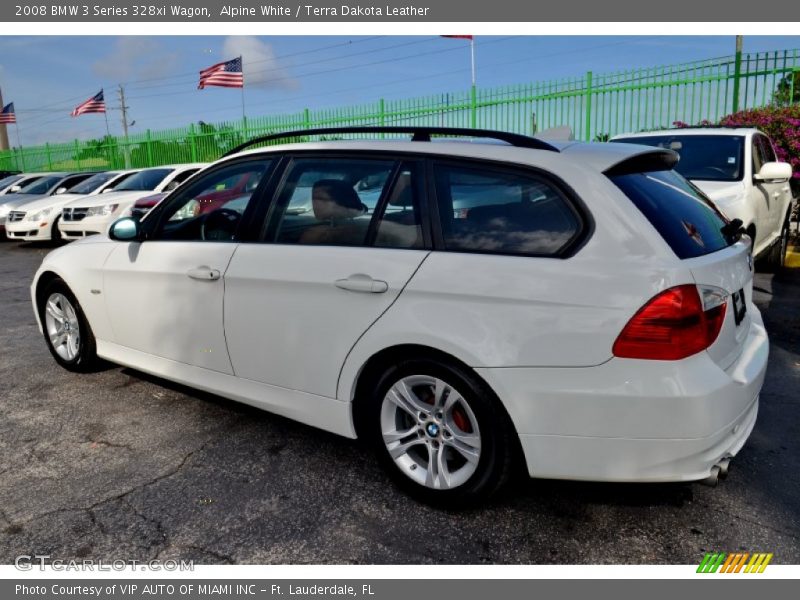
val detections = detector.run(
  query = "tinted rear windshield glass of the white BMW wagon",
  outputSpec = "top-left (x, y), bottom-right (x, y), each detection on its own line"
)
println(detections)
top-left (610, 171), bottom-right (736, 259)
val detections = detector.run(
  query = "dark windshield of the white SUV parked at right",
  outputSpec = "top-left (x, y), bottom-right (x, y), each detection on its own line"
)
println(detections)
top-left (614, 134), bottom-right (744, 181)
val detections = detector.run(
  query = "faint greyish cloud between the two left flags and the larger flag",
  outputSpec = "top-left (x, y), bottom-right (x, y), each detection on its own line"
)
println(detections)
top-left (92, 36), bottom-right (179, 81)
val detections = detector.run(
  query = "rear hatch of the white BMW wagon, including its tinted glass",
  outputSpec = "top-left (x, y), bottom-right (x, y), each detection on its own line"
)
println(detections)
top-left (606, 161), bottom-right (753, 369)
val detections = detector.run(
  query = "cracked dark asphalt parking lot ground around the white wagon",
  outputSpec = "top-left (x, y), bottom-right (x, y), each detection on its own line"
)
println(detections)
top-left (0, 242), bottom-right (800, 564)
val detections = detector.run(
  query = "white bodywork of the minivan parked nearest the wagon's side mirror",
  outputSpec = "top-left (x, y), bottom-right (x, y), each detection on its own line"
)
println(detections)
top-left (58, 163), bottom-right (206, 240)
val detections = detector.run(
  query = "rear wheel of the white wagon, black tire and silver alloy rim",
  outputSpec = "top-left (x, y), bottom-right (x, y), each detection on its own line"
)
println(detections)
top-left (362, 359), bottom-right (518, 508)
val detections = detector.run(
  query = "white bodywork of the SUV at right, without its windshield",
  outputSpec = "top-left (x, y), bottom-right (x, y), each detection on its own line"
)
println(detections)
top-left (611, 127), bottom-right (792, 257)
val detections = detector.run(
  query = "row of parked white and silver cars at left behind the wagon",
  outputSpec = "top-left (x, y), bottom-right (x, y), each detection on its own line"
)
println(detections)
top-left (0, 163), bottom-right (206, 242)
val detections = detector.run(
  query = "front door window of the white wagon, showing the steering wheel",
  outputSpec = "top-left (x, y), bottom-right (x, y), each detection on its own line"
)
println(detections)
top-left (151, 160), bottom-right (271, 242)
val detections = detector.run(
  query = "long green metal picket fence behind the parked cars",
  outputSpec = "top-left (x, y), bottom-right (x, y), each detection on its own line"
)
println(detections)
top-left (0, 49), bottom-right (800, 171)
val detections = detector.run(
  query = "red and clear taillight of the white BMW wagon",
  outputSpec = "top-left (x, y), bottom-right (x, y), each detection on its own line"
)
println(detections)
top-left (613, 285), bottom-right (728, 360)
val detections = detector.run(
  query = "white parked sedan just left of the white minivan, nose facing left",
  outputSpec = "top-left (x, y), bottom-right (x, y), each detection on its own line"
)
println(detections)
top-left (6, 170), bottom-right (138, 242)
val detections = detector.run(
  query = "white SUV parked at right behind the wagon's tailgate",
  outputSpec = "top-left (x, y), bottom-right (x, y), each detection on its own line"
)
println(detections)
top-left (611, 127), bottom-right (792, 271)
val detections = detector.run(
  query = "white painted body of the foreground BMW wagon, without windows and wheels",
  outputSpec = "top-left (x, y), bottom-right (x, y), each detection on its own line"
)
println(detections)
top-left (31, 134), bottom-right (768, 500)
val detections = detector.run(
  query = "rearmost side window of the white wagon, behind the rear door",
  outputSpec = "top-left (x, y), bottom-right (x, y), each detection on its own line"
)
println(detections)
top-left (435, 164), bottom-right (582, 256)
